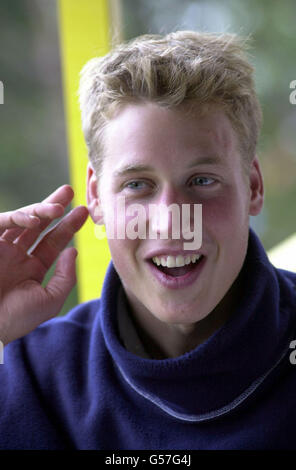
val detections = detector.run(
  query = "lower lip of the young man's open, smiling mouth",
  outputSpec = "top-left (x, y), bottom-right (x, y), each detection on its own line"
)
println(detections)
top-left (147, 252), bottom-right (206, 289)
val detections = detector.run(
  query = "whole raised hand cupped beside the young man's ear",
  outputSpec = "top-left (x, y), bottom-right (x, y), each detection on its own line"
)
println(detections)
top-left (0, 185), bottom-right (88, 345)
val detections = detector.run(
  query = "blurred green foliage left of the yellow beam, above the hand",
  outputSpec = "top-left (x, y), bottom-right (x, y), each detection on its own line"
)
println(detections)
top-left (0, 0), bottom-right (77, 314)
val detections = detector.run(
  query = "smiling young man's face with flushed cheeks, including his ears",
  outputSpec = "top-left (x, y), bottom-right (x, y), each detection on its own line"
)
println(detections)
top-left (88, 103), bottom-right (263, 325)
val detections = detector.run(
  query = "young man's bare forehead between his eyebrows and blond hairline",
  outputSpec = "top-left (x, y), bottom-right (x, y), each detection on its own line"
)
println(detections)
top-left (104, 103), bottom-right (238, 169)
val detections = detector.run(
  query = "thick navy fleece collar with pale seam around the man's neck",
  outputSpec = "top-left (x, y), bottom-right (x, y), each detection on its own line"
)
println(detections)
top-left (100, 229), bottom-right (296, 421)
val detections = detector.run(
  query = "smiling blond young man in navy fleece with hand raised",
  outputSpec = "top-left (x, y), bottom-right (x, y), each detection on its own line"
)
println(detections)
top-left (0, 31), bottom-right (296, 449)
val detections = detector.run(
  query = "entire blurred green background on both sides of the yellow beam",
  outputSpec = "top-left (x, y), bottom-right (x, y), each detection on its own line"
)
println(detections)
top-left (0, 0), bottom-right (296, 314)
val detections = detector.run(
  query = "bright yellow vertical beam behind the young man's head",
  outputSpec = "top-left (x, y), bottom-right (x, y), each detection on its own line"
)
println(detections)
top-left (57, 0), bottom-right (110, 302)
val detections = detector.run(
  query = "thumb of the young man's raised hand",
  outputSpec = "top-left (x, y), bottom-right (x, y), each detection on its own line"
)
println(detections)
top-left (45, 247), bottom-right (78, 316)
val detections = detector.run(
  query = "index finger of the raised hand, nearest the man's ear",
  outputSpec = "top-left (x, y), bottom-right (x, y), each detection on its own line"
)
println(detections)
top-left (31, 206), bottom-right (88, 269)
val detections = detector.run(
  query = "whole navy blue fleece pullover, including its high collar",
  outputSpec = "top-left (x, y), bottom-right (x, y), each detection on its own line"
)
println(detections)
top-left (0, 229), bottom-right (296, 450)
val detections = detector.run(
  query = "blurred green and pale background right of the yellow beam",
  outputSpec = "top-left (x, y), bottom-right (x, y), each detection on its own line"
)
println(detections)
top-left (122, 0), bottom-right (296, 249)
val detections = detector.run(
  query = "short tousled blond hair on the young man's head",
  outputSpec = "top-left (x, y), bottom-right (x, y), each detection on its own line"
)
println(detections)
top-left (79, 31), bottom-right (262, 176)
